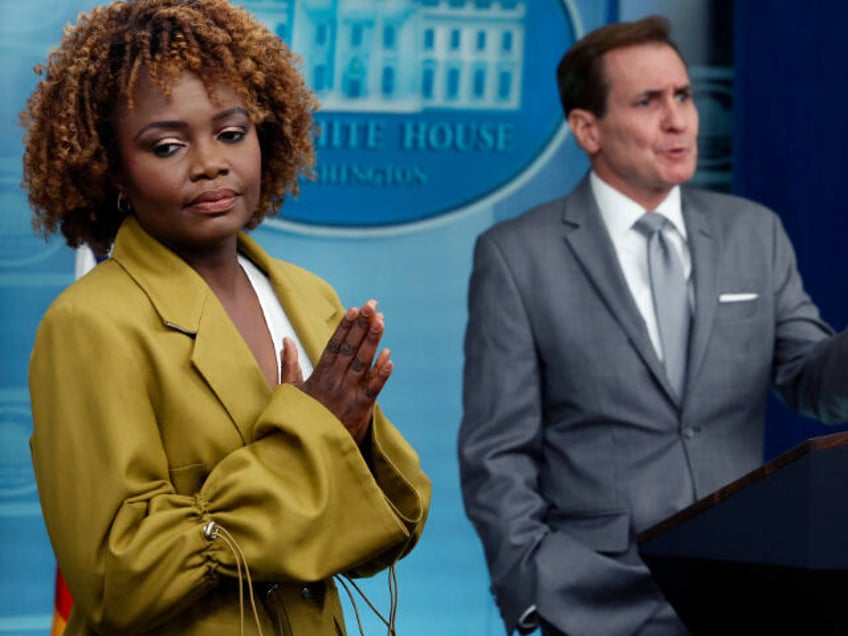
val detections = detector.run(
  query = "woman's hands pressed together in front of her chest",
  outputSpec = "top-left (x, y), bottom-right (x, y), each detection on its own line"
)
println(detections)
top-left (280, 300), bottom-right (393, 444)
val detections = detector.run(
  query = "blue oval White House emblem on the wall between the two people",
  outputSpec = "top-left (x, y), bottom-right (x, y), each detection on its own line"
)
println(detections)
top-left (242, 0), bottom-right (575, 228)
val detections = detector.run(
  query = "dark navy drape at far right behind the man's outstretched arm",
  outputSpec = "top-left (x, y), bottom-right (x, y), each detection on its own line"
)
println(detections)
top-left (732, 0), bottom-right (848, 457)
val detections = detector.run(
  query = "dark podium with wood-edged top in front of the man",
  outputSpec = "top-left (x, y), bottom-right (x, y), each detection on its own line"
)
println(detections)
top-left (638, 432), bottom-right (848, 636)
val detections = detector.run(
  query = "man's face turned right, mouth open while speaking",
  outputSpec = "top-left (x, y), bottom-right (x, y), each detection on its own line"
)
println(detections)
top-left (578, 43), bottom-right (698, 209)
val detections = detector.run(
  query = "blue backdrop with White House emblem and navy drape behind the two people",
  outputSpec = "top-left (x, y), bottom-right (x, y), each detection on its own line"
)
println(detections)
top-left (0, 0), bottom-right (848, 636)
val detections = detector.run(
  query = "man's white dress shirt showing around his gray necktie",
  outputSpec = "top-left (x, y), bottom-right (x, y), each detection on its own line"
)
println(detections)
top-left (589, 172), bottom-right (694, 360)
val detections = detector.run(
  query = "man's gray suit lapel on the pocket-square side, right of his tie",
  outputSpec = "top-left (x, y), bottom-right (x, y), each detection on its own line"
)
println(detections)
top-left (682, 189), bottom-right (719, 398)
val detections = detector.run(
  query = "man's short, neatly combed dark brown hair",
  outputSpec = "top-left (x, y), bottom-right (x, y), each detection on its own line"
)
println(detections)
top-left (557, 15), bottom-right (685, 117)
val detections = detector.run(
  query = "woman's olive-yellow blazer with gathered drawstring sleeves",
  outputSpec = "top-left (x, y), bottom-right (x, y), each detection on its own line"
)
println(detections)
top-left (29, 218), bottom-right (430, 636)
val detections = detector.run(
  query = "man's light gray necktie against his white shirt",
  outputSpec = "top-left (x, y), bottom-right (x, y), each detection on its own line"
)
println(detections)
top-left (633, 212), bottom-right (690, 397)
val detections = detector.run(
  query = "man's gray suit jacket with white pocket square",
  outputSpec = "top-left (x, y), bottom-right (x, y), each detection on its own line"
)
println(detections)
top-left (459, 178), bottom-right (848, 636)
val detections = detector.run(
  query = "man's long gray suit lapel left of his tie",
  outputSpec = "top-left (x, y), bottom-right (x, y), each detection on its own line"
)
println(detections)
top-left (563, 176), bottom-right (677, 402)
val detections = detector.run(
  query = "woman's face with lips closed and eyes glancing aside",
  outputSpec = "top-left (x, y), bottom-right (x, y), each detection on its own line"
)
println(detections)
top-left (114, 71), bottom-right (262, 258)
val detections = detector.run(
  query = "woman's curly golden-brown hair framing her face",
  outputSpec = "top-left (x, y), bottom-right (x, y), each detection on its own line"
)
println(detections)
top-left (21, 0), bottom-right (318, 253)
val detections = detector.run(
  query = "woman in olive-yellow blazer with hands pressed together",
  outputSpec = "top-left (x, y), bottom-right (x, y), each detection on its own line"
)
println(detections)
top-left (23, 0), bottom-right (430, 636)
